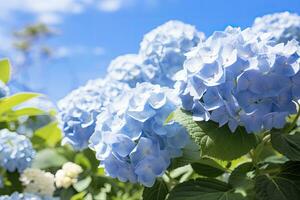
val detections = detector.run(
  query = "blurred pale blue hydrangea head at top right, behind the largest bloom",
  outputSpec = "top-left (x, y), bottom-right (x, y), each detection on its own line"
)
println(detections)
top-left (252, 12), bottom-right (300, 43)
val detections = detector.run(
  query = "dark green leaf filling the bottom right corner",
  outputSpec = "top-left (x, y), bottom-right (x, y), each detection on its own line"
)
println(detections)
top-left (255, 175), bottom-right (300, 200)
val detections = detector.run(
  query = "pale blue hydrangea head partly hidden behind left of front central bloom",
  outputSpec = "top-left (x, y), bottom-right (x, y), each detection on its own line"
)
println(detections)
top-left (58, 79), bottom-right (129, 150)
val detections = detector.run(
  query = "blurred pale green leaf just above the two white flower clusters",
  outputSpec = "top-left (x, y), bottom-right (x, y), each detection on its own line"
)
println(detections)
top-left (32, 149), bottom-right (68, 169)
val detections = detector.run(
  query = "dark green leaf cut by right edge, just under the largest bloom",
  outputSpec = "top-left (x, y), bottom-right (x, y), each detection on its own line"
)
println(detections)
top-left (271, 132), bottom-right (300, 161)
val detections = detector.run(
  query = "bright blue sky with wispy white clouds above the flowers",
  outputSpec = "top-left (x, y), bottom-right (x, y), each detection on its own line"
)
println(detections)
top-left (0, 0), bottom-right (300, 100)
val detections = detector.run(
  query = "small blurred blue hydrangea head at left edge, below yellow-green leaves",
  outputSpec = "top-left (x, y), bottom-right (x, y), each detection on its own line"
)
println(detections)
top-left (0, 129), bottom-right (35, 172)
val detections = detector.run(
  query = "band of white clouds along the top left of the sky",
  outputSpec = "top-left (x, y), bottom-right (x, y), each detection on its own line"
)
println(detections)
top-left (0, 0), bottom-right (158, 24)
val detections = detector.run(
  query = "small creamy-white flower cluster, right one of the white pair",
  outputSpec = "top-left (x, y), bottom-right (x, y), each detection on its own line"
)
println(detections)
top-left (55, 162), bottom-right (83, 189)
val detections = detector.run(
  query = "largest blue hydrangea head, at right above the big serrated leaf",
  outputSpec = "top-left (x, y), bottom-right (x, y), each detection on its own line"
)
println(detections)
top-left (176, 27), bottom-right (300, 133)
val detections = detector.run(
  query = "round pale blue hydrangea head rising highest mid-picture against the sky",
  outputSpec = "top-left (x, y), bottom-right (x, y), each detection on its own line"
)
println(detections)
top-left (139, 21), bottom-right (205, 87)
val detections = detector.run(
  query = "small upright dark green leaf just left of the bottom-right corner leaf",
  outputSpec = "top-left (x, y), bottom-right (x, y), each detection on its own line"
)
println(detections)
top-left (228, 162), bottom-right (254, 191)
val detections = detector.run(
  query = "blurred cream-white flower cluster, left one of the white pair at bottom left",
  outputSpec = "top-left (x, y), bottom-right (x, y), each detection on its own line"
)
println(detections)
top-left (20, 168), bottom-right (55, 197)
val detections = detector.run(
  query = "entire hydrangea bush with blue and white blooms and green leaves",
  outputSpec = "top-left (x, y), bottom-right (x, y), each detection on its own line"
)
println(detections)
top-left (0, 13), bottom-right (300, 200)
